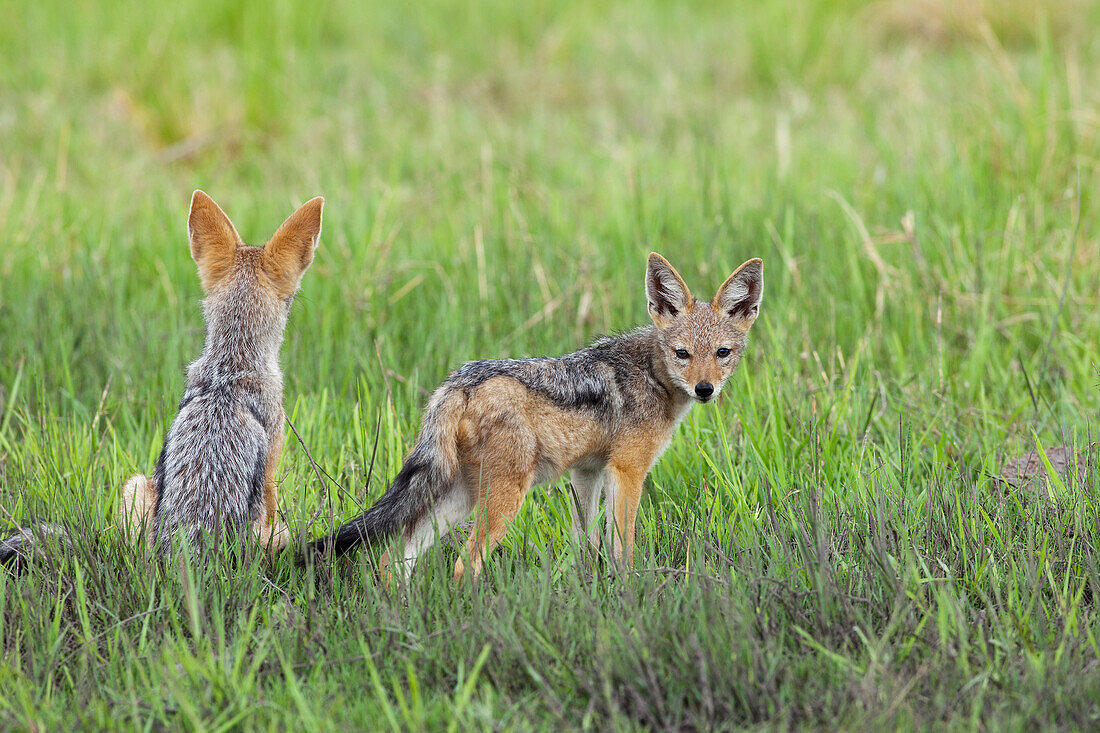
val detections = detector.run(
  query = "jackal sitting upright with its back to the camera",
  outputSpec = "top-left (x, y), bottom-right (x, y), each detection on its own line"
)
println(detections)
top-left (119, 190), bottom-right (325, 554)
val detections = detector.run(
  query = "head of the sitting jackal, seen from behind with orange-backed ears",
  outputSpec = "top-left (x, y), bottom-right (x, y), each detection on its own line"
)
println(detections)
top-left (187, 190), bottom-right (325, 351)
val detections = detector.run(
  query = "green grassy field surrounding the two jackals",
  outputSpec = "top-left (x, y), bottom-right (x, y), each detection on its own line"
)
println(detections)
top-left (0, 0), bottom-right (1100, 730)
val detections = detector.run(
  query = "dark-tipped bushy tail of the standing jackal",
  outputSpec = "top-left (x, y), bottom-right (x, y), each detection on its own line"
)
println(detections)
top-left (299, 385), bottom-right (466, 561)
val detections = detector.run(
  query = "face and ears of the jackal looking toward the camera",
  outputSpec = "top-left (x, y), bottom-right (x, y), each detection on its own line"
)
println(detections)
top-left (646, 252), bottom-right (763, 402)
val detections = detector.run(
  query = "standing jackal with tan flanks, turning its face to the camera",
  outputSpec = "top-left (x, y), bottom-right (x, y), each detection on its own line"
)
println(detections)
top-left (309, 253), bottom-right (763, 579)
